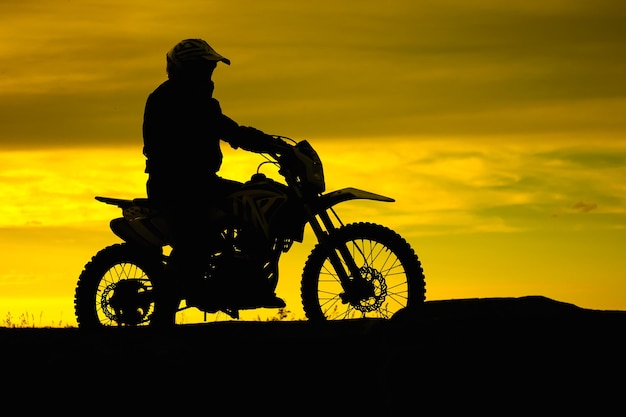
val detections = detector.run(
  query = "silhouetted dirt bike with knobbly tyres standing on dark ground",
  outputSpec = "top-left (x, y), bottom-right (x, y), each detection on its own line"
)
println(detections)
top-left (74, 136), bottom-right (426, 328)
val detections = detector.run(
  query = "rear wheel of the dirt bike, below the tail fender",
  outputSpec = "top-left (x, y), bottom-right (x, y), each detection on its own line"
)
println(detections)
top-left (74, 243), bottom-right (164, 329)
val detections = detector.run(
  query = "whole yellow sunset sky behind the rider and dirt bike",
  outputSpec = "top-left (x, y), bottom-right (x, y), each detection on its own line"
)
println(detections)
top-left (0, 0), bottom-right (626, 323)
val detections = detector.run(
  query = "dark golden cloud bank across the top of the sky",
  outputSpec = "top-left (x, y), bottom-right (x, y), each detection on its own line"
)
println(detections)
top-left (0, 0), bottom-right (626, 148)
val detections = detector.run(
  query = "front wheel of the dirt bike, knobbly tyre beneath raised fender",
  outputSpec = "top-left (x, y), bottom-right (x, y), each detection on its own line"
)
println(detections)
top-left (301, 223), bottom-right (426, 321)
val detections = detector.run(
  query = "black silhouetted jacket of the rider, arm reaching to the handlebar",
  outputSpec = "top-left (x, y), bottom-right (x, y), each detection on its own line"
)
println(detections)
top-left (143, 79), bottom-right (276, 202)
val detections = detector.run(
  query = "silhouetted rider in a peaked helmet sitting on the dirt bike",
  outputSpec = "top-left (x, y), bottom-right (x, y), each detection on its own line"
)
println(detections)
top-left (143, 39), bottom-right (285, 318)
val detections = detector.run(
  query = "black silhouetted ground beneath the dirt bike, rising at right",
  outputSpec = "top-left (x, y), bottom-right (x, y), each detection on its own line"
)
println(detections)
top-left (0, 296), bottom-right (626, 415)
